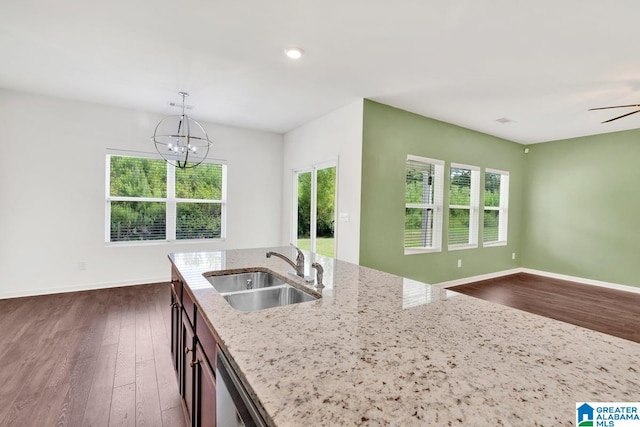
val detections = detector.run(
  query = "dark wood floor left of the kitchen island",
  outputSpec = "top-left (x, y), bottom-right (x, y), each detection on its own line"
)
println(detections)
top-left (0, 284), bottom-right (185, 427)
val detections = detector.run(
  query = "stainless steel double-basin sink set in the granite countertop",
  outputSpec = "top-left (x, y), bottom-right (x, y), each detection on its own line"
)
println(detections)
top-left (204, 270), bottom-right (319, 311)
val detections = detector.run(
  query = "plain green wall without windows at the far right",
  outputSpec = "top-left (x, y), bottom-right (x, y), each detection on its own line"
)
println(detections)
top-left (522, 125), bottom-right (640, 286)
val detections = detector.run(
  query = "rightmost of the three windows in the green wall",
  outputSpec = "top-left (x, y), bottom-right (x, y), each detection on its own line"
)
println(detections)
top-left (482, 169), bottom-right (509, 246)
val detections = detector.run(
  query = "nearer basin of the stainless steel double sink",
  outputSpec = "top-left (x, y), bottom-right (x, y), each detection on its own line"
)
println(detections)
top-left (224, 284), bottom-right (317, 311)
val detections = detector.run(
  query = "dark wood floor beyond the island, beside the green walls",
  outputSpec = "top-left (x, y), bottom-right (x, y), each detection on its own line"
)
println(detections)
top-left (449, 273), bottom-right (640, 342)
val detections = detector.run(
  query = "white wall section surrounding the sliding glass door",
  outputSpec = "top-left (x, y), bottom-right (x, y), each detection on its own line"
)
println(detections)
top-left (282, 99), bottom-right (364, 264)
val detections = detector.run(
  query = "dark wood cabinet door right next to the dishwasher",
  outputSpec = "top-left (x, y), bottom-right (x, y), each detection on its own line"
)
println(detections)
top-left (196, 343), bottom-right (216, 427)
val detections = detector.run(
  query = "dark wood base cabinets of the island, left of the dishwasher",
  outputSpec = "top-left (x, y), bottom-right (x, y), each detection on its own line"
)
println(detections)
top-left (171, 269), bottom-right (217, 427)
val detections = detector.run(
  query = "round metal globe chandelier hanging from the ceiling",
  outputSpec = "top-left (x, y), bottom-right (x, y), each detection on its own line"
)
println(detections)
top-left (151, 92), bottom-right (212, 169)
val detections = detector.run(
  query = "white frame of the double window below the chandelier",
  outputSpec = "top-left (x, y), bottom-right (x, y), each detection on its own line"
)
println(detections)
top-left (104, 150), bottom-right (227, 246)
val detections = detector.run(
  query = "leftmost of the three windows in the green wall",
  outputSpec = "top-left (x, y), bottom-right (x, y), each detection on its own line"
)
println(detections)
top-left (404, 155), bottom-right (444, 254)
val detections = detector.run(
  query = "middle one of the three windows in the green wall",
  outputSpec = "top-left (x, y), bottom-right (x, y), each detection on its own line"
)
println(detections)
top-left (448, 163), bottom-right (480, 250)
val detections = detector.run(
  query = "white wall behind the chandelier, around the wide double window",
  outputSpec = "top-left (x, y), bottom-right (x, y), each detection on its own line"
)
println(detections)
top-left (0, 90), bottom-right (283, 298)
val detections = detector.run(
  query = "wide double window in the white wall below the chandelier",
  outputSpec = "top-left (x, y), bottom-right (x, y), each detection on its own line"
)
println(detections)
top-left (105, 154), bottom-right (226, 242)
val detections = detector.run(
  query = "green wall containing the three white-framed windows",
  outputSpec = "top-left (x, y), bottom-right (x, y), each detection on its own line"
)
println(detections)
top-left (360, 100), bottom-right (526, 283)
